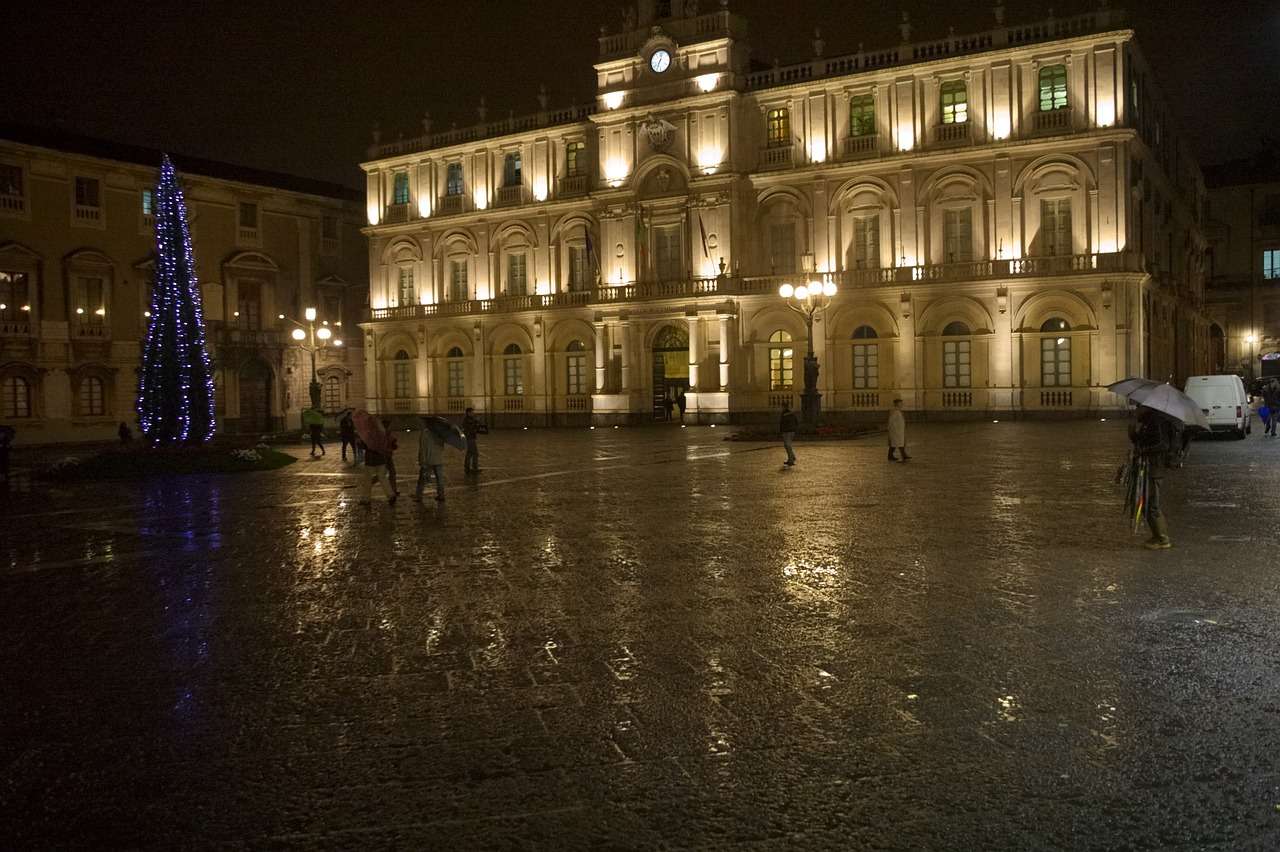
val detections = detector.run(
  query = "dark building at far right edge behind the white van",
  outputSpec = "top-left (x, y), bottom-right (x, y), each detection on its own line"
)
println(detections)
top-left (1206, 152), bottom-right (1280, 380)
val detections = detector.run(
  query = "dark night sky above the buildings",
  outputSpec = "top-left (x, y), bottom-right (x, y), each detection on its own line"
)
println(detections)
top-left (0, 0), bottom-right (1280, 187)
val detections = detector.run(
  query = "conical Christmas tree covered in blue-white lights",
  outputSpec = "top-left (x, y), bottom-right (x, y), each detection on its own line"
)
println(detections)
top-left (138, 156), bottom-right (214, 445)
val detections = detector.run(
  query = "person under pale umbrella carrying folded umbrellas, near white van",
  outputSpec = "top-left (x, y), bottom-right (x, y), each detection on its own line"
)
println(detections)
top-left (1107, 379), bottom-right (1208, 550)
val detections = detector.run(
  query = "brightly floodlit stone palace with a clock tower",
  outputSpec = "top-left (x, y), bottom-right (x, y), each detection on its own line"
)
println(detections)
top-left (362, 0), bottom-right (1208, 423)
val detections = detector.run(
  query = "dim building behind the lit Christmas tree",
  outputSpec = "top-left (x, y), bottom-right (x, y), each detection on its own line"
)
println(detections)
top-left (0, 128), bottom-right (367, 443)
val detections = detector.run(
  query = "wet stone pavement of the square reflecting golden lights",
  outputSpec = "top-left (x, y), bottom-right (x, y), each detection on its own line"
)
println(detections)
top-left (0, 422), bottom-right (1280, 849)
